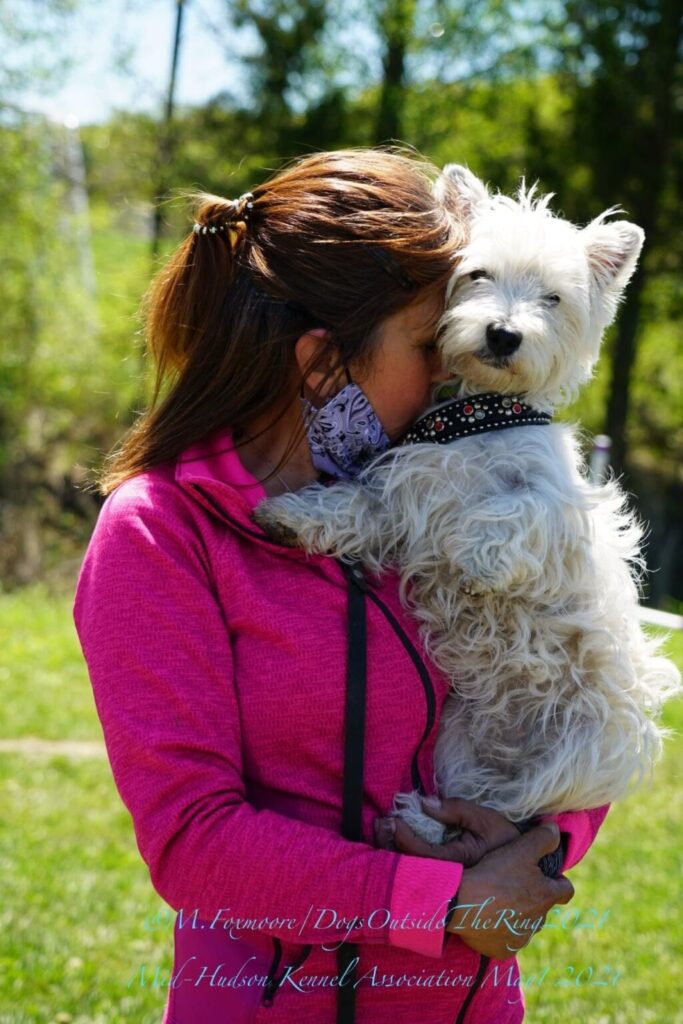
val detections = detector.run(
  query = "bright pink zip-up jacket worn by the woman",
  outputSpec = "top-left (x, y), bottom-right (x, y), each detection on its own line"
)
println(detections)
top-left (74, 431), bottom-right (606, 1024)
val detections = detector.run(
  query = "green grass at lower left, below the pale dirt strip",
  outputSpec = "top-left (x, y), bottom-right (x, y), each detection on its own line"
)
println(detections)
top-left (0, 755), bottom-right (172, 1024)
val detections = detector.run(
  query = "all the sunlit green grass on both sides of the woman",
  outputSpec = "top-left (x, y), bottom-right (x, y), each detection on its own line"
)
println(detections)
top-left (0, 587), bottom-right (683, 1024)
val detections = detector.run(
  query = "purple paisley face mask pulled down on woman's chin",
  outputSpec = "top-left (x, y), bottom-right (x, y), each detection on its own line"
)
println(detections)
top-left (300, 370), bottom-right (390, 480)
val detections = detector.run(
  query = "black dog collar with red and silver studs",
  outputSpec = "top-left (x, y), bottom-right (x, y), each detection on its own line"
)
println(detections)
top-left (397, 391), bottom-right (552, 445)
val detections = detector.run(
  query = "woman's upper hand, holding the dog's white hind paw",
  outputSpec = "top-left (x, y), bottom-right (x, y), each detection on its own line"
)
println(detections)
top-left (375, 797), bottom-right (519, 867)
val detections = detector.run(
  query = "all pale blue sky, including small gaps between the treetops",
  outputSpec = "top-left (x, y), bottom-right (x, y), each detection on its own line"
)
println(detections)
top-left (7, 0), bottom-right (557, 126)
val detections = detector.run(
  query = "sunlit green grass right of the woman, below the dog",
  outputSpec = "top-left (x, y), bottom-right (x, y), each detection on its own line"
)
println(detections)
top-left (520, 635), bottom-right (683, 1024)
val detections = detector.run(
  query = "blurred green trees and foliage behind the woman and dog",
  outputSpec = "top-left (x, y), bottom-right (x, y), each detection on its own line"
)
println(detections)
top-left (0, 0), bottom-right (683, 598)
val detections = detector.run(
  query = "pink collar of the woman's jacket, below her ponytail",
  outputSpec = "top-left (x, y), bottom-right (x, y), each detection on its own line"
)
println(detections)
top-left (175, 428), bottom-right (317, 560)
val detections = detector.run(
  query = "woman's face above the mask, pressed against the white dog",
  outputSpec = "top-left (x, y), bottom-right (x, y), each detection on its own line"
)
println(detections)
top-left (349, 293), bottom-right (449, 441)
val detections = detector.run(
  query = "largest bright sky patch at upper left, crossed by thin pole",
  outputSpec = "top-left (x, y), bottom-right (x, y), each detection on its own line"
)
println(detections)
top-left (18, 0), bottom-right (251, 124)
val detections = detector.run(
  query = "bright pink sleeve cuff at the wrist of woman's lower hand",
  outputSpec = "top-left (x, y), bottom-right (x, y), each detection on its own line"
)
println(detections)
top-left (389, 855), bottom-right (464, 956)
